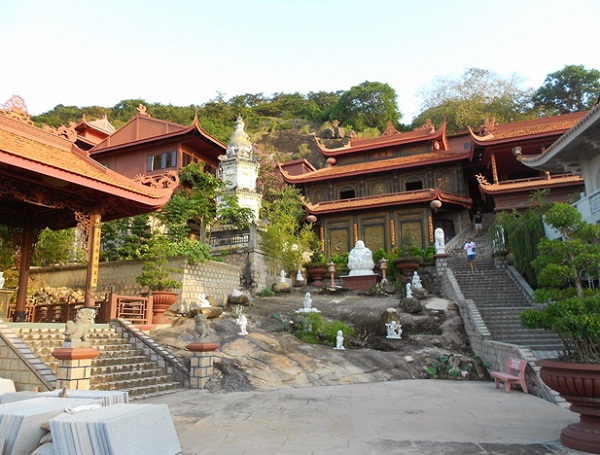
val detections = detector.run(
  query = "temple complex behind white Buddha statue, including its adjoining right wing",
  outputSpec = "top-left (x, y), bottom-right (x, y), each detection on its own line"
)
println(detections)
top-left (280, 112), bottom-right (586, 256)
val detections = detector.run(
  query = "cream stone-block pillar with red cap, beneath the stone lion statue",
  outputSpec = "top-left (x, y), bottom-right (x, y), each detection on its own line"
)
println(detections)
top-left (52, 347), bottom-right (100, 390)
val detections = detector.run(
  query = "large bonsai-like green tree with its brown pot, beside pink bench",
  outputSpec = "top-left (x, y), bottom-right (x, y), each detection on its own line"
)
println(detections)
top-left (521, 203), bottom-right (600, 453)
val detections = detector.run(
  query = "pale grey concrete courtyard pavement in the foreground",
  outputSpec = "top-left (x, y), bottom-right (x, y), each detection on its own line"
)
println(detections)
top-left (135, 380), bottom-right (583, 455)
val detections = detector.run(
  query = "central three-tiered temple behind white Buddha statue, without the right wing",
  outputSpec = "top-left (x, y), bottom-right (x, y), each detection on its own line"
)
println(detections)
top-left (280, 122), bottom-right (473, 256)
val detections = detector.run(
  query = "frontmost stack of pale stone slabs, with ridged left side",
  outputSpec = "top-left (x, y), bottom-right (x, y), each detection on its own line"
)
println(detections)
top-left (50, 404), bottom-right (181, 455)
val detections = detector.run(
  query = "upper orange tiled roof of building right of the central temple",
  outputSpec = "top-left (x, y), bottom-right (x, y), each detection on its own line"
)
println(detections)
top-left (471, 112), bottom-right (585, 144)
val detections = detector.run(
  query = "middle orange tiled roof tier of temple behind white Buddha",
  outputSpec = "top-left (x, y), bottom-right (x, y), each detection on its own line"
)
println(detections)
top-left (281, 151), bottom-right (470, 183)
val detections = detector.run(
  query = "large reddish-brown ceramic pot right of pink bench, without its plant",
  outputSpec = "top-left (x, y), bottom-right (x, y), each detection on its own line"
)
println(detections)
top-left (537, 360), bottom-right (600, 453)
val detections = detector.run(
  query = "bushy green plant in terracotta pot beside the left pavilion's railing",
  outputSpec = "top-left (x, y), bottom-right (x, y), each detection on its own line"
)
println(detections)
top-left (135, 235), bottom-right (182, 324)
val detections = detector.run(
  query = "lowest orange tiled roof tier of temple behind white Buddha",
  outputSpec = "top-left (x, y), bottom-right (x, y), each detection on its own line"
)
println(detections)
top-left (306, 188), bottom-right (473, 214)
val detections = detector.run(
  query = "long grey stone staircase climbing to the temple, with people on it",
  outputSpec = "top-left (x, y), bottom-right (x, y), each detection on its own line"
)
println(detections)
top-left (447, 230), bottom-right (563, 358)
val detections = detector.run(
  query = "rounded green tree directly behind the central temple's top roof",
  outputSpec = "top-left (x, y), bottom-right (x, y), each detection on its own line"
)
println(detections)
top-left (329, 81), bottom-right (402, 131)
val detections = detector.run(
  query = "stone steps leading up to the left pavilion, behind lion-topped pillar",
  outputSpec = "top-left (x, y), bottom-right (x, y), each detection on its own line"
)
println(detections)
top-left (14, 324), bottom-right (181, 399)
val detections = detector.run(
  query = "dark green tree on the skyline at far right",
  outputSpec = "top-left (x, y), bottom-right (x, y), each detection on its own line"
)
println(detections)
top-left (532, 65), bottom-right (600, 115)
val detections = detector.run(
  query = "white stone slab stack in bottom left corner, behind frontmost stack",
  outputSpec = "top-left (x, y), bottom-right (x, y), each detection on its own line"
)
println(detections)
top-left (0, 397), bottom-right (100, 455)
